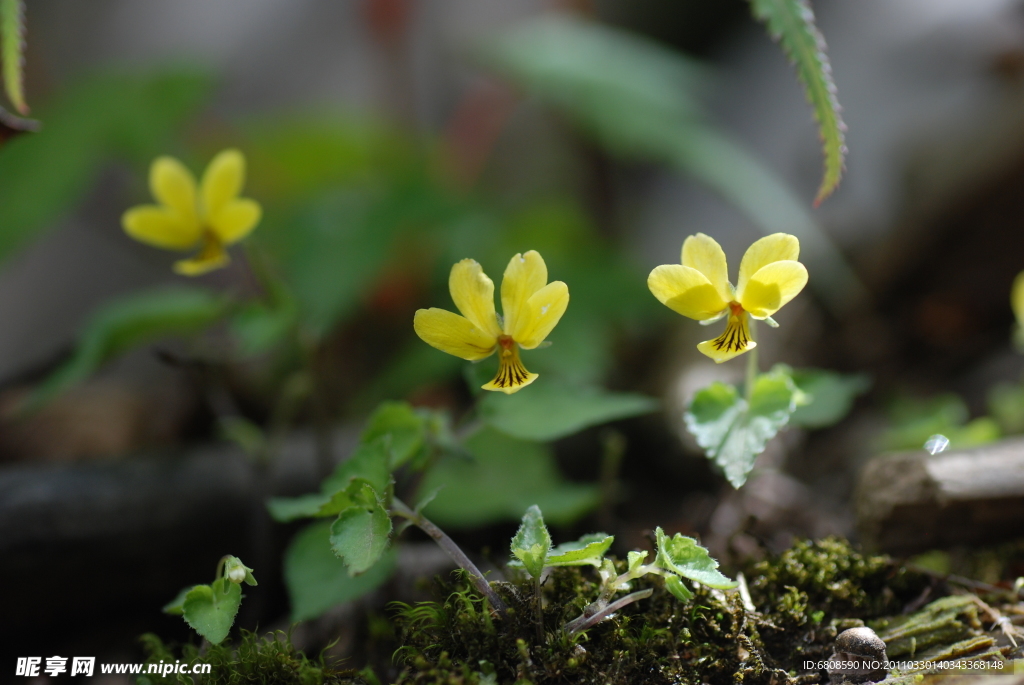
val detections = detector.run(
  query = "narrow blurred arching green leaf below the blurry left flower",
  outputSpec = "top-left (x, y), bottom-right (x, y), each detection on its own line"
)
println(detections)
top-left (27, 286), bottom-right (230, 410)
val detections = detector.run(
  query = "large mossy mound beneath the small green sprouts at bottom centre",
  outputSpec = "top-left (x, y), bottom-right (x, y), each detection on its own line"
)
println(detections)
top-left (395, 539), bottom-right (929, 685)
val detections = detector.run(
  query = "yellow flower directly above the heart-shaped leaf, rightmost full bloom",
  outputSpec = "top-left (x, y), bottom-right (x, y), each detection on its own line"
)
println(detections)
top-left (647, 233), bottom-right (807, 363)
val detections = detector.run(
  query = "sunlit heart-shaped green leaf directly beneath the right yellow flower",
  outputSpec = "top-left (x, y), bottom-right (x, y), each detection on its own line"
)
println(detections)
top-left (683, 372), bottom-right (799, 487)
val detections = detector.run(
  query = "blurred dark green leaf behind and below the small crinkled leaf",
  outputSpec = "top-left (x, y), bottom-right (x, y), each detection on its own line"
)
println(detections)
top-left (285, 521), bottom-right (397, 620)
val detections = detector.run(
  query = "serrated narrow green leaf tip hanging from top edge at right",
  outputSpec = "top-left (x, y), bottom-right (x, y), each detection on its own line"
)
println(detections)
top-left (751, 0), bottom-right (846, 205)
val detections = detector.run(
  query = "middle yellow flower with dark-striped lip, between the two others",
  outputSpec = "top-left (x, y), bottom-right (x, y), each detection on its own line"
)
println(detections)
top-left (413, 250), bottom-right (569, 395)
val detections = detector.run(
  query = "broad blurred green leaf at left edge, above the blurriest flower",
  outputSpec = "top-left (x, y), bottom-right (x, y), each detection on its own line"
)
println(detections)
top-left (0, 71), bottom-right (212, 260)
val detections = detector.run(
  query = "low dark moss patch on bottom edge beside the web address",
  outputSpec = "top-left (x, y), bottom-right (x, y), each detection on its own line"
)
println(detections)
top-left (136, 631), bottom-right (366, 685)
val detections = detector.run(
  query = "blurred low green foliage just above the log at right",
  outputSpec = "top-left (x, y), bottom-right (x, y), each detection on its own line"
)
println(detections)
top-left (880, 392), bottom-right (1000, 449)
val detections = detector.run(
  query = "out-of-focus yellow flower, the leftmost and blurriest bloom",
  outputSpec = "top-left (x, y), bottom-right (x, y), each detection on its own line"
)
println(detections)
top-left (121, 149), bottom-right (262, 275)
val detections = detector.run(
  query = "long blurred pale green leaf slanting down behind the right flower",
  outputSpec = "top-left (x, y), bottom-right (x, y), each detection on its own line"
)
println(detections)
top-left (480, 15), bottom-right (865, 310)
